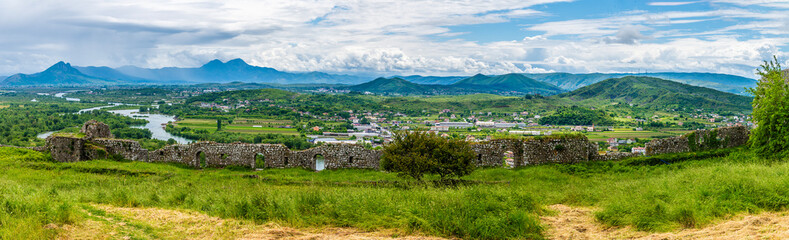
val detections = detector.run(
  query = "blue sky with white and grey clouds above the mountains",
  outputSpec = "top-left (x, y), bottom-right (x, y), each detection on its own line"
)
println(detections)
top-left (0, 0), bottom-right (789, 78)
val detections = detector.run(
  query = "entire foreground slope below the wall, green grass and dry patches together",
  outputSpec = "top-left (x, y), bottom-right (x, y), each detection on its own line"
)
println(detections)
top-left (0, 145), bottom-right (789, 239)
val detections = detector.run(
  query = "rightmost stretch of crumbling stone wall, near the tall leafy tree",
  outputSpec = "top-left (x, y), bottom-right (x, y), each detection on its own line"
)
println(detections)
top-left (646, 126), bottom-right (750, 156)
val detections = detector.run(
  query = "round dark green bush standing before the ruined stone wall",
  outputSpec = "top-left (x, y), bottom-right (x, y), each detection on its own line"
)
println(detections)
top-left (381, 132), bottom-right (474, 181)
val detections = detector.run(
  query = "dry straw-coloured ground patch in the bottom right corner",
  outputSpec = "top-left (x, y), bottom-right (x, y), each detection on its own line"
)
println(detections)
top-left (541, 204), bottom-right (789, 239)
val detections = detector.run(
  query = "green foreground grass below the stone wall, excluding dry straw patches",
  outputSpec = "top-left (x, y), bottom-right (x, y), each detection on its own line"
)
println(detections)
top-left (0, 145), bottom-right (789, 239)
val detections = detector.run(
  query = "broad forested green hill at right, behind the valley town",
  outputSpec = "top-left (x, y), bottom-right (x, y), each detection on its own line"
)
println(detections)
top-left (557, 76), bottom-right (753, 111)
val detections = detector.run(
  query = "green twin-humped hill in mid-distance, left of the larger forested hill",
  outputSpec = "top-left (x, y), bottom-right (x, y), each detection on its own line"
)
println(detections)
top-left (451, 73), bottom-right (562, 95)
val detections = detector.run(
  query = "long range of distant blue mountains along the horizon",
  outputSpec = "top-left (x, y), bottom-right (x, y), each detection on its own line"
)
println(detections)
top-left (0, 59), bottom-right (756, 95)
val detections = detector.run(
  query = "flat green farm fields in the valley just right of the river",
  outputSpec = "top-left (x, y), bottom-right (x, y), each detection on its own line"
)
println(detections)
top-left (176, 119), bottom-right (299, 135)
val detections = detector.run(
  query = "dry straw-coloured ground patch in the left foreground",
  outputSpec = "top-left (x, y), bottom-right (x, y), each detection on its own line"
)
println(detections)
top-left (59, 205), bottom-right (442, 239)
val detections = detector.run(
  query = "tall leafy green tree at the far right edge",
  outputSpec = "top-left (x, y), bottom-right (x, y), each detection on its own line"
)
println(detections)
top-left (747, 57), bottom-right (789, 157)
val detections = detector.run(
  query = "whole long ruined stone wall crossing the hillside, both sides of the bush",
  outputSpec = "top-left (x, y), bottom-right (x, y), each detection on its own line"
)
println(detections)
top-left (44, 121), bottom-right (748, 170)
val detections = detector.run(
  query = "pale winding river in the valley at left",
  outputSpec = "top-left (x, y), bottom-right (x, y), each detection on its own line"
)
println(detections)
top-left (36, 93), bottom-right (193, 144)
